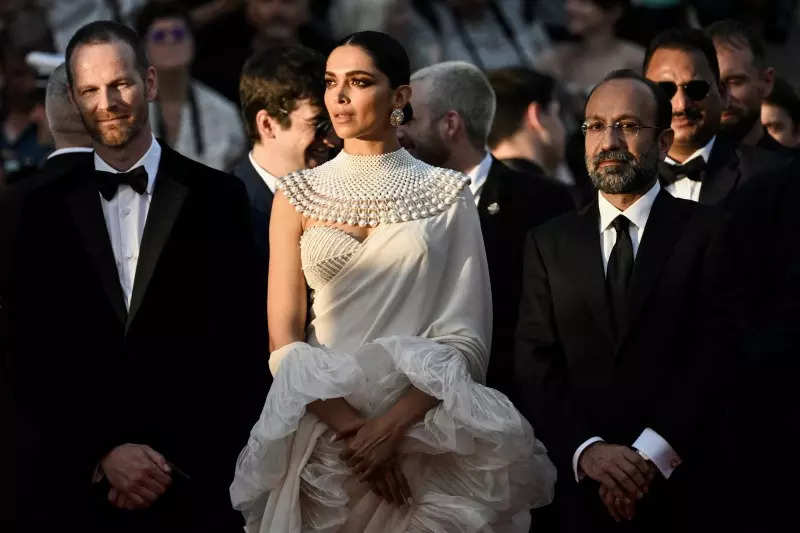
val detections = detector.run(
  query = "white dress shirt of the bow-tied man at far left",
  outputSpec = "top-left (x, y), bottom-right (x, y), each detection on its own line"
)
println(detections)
top-left (94, 137), bottom-right (161, 308)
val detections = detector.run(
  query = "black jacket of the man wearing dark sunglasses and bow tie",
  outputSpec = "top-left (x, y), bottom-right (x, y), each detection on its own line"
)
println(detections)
top-left (662, 135), bottom-right (793, 208)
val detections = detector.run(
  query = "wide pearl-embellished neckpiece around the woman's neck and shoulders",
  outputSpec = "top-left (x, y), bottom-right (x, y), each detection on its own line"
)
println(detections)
top-left (278, 148), bottom-right (470, 227)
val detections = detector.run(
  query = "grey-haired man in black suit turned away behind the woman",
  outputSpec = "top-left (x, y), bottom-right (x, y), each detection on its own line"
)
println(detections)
top-left (398, 61), bottom-right (572, 396)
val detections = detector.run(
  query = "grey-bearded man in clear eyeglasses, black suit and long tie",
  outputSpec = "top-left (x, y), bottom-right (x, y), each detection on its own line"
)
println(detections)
top-left (515, 70), bottom-right (724, 533)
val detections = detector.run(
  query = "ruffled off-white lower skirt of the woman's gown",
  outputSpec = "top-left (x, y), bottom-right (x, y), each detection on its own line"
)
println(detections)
top-left (230, 337), bottom-right (556, 533)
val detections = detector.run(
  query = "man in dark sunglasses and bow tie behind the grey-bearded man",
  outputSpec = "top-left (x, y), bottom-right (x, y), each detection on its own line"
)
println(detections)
top-left (643, 29), bottom-right (788, 205)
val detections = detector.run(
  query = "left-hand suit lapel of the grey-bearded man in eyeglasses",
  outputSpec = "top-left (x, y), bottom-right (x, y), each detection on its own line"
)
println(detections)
top-left (566, 199), bottom-right (614, 345)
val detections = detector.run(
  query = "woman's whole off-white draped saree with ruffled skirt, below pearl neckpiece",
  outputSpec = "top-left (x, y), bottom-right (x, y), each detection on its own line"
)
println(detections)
top-left (230, 150), bottom-right (555, 533)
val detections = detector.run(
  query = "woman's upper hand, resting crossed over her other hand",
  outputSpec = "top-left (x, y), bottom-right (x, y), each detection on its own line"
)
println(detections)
top-left (339, 413), bottom-right (406, 481)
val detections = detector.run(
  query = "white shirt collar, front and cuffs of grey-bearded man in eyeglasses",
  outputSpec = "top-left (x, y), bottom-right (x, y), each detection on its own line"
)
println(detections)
top-left (572, 181), bottom-right (681, 481)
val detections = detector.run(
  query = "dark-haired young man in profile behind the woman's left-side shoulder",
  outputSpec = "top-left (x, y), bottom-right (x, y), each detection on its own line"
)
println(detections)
top-left (233, 46), bottom-right (339, 336)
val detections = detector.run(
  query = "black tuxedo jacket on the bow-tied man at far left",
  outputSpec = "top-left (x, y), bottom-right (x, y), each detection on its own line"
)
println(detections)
top-left (11, 144), bottom-right (267, 531)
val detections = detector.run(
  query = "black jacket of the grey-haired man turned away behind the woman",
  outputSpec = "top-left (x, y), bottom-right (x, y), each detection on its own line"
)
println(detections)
top-left (478, 159), bottom-right (572, 396)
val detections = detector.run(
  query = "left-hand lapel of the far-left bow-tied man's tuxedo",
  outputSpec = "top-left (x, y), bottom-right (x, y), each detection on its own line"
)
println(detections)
top-left (66, 180), bottom-right (127, 323)
